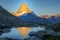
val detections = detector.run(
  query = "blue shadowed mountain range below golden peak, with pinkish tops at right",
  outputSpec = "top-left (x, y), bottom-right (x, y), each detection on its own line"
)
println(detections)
top-left (18, 11), bottom-right (60, 24)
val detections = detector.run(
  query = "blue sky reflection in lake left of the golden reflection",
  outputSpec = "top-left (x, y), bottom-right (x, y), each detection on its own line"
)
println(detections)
top-left (0, 28), bottom-right (22, 39)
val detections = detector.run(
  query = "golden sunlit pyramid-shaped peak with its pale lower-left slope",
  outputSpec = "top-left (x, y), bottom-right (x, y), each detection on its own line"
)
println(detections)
top-left (13, 2), bottom-right (31, 16)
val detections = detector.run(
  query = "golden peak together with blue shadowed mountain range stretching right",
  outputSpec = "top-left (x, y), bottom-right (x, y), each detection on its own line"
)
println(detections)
top-left (12, 3), bottom-right (60, 25)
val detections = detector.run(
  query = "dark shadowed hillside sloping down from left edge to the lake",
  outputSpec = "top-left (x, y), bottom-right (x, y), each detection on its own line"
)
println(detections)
top-left (0, 6), bottom-right (21, 34)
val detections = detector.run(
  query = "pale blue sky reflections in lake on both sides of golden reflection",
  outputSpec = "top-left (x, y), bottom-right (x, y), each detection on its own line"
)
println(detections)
top-left (0, 27), bottom-right (45, 39)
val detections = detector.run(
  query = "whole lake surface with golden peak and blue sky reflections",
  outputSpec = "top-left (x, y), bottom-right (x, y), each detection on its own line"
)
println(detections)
top-left (0, 27), bottom-right (45, 39)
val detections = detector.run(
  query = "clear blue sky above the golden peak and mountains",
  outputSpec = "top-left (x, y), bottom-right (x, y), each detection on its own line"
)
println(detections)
top-left (0, 0), bottom-right (60, 16)
